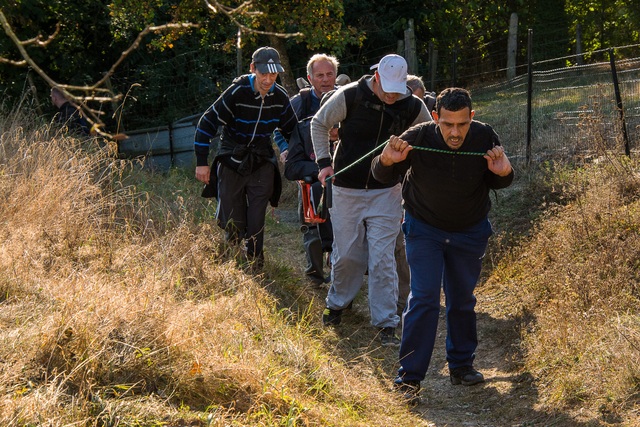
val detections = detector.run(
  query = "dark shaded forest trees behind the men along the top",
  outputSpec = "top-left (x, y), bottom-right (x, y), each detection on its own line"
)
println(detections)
top-left (0, 0), bottom-right (640, 131)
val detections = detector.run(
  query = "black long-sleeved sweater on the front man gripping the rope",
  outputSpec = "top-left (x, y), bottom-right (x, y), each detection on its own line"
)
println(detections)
top-left (372, 121), bottom-right (514, 231)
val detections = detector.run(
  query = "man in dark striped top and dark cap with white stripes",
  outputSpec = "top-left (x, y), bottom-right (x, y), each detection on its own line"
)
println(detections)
top-left (194, 47), bottom-right (298, 267)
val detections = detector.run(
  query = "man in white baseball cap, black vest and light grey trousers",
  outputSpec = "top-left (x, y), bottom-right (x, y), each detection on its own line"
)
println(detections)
top-left (311, 54), bottom-right (431, 347)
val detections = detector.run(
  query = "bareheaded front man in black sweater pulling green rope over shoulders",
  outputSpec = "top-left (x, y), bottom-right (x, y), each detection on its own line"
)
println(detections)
top-left (371, 88), bottom-right (513, 403)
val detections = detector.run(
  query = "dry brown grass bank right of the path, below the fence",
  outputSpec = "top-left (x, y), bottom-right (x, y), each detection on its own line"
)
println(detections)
top-left (485, 108), bottom-right (640, 426)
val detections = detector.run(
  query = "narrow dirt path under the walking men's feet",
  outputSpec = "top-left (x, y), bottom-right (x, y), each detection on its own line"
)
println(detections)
top-left (267, 210), bottom-right (596, 427)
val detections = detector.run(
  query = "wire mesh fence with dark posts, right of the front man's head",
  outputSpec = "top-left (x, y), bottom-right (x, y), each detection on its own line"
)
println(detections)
top-left (471, 44), bottom-right (640, 163)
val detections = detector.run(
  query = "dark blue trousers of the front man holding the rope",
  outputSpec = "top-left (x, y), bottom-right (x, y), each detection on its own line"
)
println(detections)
top-left (398, 212), bottom-right (492, 381)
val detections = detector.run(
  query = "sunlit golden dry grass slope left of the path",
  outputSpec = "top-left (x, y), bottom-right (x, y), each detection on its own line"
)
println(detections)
top-left (0, 112), bottom-right (430, 426)
